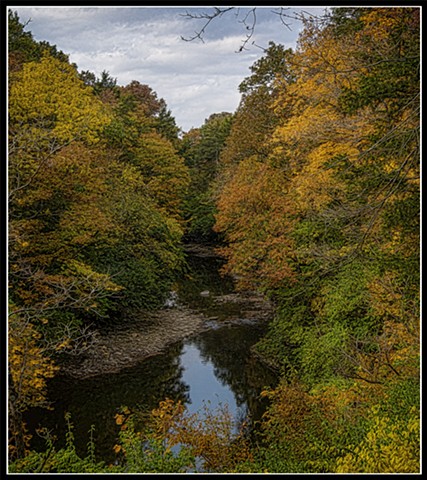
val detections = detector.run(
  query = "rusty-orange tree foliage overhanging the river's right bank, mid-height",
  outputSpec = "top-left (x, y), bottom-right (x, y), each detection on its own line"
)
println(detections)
top-left (215, 158), bottom-right (293, 286)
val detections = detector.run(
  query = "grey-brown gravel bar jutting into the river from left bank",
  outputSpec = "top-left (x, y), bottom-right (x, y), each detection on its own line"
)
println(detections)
top-left (62, 291), bottom-right (273, 379)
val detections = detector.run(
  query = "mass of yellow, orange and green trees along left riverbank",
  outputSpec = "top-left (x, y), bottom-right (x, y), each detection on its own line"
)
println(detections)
top-left (8, 8), bottom-right (189, 464)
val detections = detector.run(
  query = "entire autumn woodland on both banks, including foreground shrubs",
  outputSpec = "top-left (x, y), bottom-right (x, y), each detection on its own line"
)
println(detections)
top-left (8, 7), bottom-right (420, 473)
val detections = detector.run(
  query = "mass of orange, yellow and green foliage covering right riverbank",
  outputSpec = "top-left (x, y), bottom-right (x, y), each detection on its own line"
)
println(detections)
top-left (215, 8), bottom-right (420, 473)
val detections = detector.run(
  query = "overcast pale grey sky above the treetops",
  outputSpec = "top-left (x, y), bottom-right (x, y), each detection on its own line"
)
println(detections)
top-left (9, 5), bottom-right (325, 131)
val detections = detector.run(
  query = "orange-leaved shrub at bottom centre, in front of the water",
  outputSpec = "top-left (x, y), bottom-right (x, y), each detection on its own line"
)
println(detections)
top-left (113, 398), bottom-right (253, 473)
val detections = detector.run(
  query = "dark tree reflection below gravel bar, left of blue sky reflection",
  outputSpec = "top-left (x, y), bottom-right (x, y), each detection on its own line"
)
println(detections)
top-left (27, 344), bottom-right (189, 461)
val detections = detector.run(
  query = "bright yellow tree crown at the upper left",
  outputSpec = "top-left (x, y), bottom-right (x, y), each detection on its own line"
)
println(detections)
top-left (9, 56), bottom-right (109, 206)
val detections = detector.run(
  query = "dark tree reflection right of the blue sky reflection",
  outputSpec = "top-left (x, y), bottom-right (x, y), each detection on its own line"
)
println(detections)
top-left (193, 325), bottom-right (276, 420)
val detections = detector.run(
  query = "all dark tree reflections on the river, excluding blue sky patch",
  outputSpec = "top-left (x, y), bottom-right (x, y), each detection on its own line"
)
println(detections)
top-left (26, 251), bottom-right (275, 462)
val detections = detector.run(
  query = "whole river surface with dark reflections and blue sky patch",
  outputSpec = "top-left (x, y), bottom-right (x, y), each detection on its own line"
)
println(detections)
top-left (27, 246), bottom-right (277, 463)
